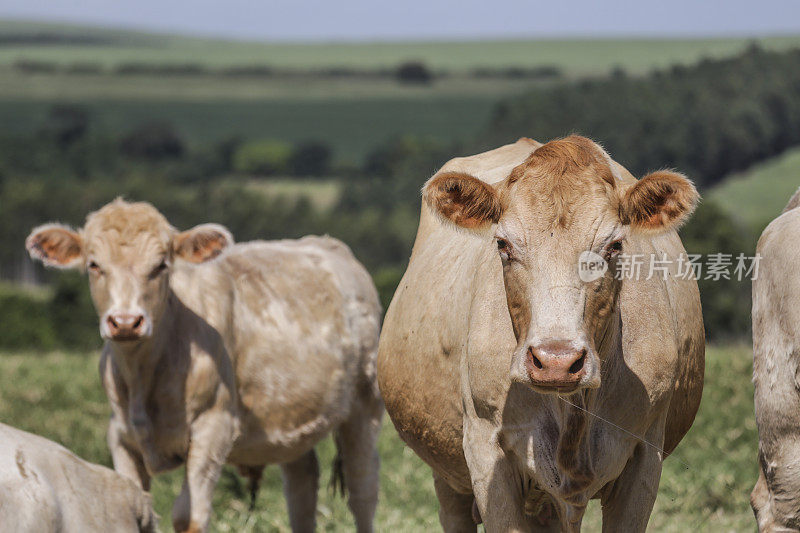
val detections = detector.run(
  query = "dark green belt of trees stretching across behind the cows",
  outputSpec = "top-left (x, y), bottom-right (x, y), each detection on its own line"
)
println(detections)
top-left (0, 44), bottom-right (800, 347)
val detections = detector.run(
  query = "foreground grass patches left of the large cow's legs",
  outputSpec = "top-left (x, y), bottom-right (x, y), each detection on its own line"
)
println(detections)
top-left (0, 353), bottom-right (436, 532)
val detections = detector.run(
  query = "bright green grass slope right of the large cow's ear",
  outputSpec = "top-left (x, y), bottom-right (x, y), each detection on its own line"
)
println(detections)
top-left (706, 148), bottom-right (800, 236)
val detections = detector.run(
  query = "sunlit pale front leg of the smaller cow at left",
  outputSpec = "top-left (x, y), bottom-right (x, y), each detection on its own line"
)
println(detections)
top-left (172, 412), bottom-right (237, 533)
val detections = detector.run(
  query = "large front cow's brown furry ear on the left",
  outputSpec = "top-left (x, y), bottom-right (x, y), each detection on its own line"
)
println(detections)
top-left (422, 172), bottom-right (503, 228)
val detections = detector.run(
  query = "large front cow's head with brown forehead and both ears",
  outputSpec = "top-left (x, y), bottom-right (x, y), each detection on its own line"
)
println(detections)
top-left (423, 136), bottom-right (698, 393)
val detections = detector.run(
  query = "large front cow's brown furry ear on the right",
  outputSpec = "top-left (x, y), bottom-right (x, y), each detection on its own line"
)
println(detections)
top-left (620, 170), bottom-right (700, 232)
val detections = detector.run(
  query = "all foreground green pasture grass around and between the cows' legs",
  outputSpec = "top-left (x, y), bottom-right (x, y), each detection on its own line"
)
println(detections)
top-left (0, 345), bottom-right (757, 532)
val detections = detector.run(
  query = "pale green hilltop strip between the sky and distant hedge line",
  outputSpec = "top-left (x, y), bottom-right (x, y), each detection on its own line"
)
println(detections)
top-left (0, 20), bottom-right (800, 75)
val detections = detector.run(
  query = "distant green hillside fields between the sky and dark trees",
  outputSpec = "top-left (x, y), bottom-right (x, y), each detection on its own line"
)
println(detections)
top-left (6, 20), bottom-right (800, 164)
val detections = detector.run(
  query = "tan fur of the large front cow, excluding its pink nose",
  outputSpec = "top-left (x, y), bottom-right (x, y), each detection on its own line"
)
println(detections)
top-left (378, 137), bottom-right (704, 532)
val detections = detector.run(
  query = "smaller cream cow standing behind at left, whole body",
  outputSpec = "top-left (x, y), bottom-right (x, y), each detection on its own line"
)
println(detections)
top-left (27, 200), bottom-right (383, 531)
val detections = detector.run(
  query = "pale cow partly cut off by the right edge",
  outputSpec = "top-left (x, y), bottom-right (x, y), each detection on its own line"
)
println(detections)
top-left (750, 197), bottom-right (800, 532)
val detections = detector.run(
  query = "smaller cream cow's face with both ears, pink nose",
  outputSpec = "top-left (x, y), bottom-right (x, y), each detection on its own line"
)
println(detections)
top-left (26, 200), bottom-right (233, 342)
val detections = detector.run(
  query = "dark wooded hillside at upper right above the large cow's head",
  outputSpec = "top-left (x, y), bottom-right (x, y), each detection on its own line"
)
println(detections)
top-left (476, 45), bottom-right (800, 186)
